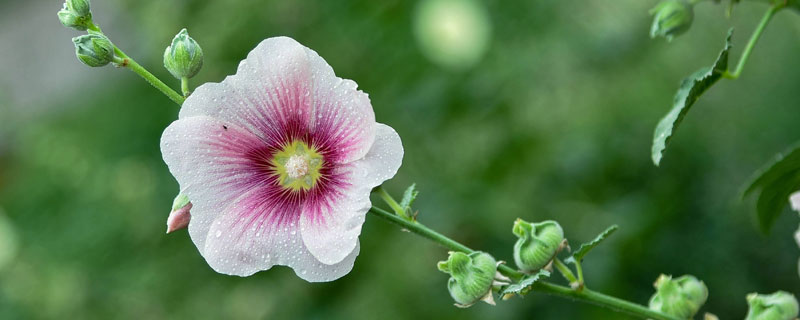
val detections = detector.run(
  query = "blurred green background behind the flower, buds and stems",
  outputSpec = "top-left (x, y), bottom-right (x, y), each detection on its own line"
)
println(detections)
top-left (0, 0), bottom-right (800, 319)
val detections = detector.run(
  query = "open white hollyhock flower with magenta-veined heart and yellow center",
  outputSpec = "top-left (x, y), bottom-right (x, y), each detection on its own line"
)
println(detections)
top-left (161, 37), bottom-right (403, 281)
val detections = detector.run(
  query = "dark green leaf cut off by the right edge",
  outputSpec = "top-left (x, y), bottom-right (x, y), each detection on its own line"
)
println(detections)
top-left (742, 143), bottom-right (800, 234)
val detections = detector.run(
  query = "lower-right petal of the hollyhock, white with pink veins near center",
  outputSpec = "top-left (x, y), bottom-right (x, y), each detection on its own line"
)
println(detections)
top-left (300, 123), bottom-right (403, 264)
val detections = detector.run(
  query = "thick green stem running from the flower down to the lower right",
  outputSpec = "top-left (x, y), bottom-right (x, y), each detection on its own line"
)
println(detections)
top-left (369, 207), bottom-right (679, 320)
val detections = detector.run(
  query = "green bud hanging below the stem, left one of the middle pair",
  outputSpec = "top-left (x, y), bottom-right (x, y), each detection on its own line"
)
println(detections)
top-left (437, 252), bottom-right (497, 308)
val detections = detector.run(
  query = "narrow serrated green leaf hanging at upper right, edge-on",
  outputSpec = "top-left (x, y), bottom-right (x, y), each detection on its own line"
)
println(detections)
top-left (651, 29), bottom-right (733, 166)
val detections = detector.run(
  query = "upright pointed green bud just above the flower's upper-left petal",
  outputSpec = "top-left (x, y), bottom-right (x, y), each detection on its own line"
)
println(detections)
top-left (164, 28), bottom-right (203, 79)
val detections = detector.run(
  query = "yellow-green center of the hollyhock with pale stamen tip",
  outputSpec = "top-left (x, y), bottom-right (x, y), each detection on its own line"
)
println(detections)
top-left (272, 140), bottom-right (322, 191)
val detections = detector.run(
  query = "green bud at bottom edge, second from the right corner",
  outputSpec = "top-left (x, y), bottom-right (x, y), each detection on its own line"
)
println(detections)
top-left (650, 274), bottom-right (708, 319)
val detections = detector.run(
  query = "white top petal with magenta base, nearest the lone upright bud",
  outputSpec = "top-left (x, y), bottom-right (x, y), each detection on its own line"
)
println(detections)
top-left (179, 37), bottom-right (313, 144)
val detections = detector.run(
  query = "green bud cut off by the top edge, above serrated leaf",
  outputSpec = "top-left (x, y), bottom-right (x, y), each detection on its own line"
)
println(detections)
top-left (650, 0), bottom-right (694, 41)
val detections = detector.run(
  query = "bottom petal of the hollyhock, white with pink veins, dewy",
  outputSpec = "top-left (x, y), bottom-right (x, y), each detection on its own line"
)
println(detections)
top-left (201, 185), bottom-right (359, 282)
